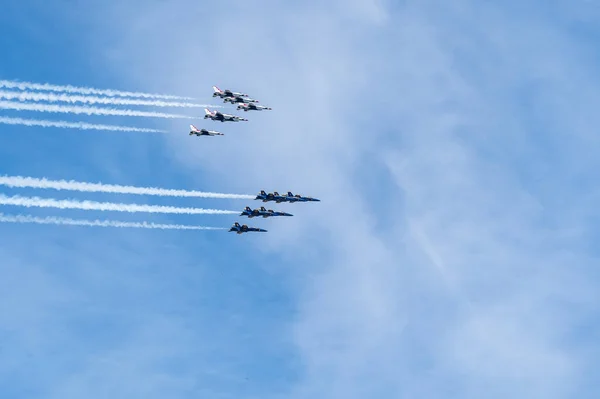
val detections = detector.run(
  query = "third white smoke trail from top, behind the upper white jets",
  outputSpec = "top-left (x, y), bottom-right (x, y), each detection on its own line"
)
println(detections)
top-left (0, 101), bottom-right (198, 119)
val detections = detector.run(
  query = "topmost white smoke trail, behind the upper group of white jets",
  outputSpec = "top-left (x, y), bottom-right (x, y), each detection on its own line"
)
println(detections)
top-left (0, 80), bottom-right (194, 100)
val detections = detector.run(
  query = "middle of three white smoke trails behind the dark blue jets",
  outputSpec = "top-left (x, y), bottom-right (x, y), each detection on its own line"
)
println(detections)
top-left (0, 194), bottom-right (238, 215)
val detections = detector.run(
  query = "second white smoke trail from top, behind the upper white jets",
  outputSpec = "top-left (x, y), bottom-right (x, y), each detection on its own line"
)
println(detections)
top-left (0, 91), bottom-right (218, 108)
